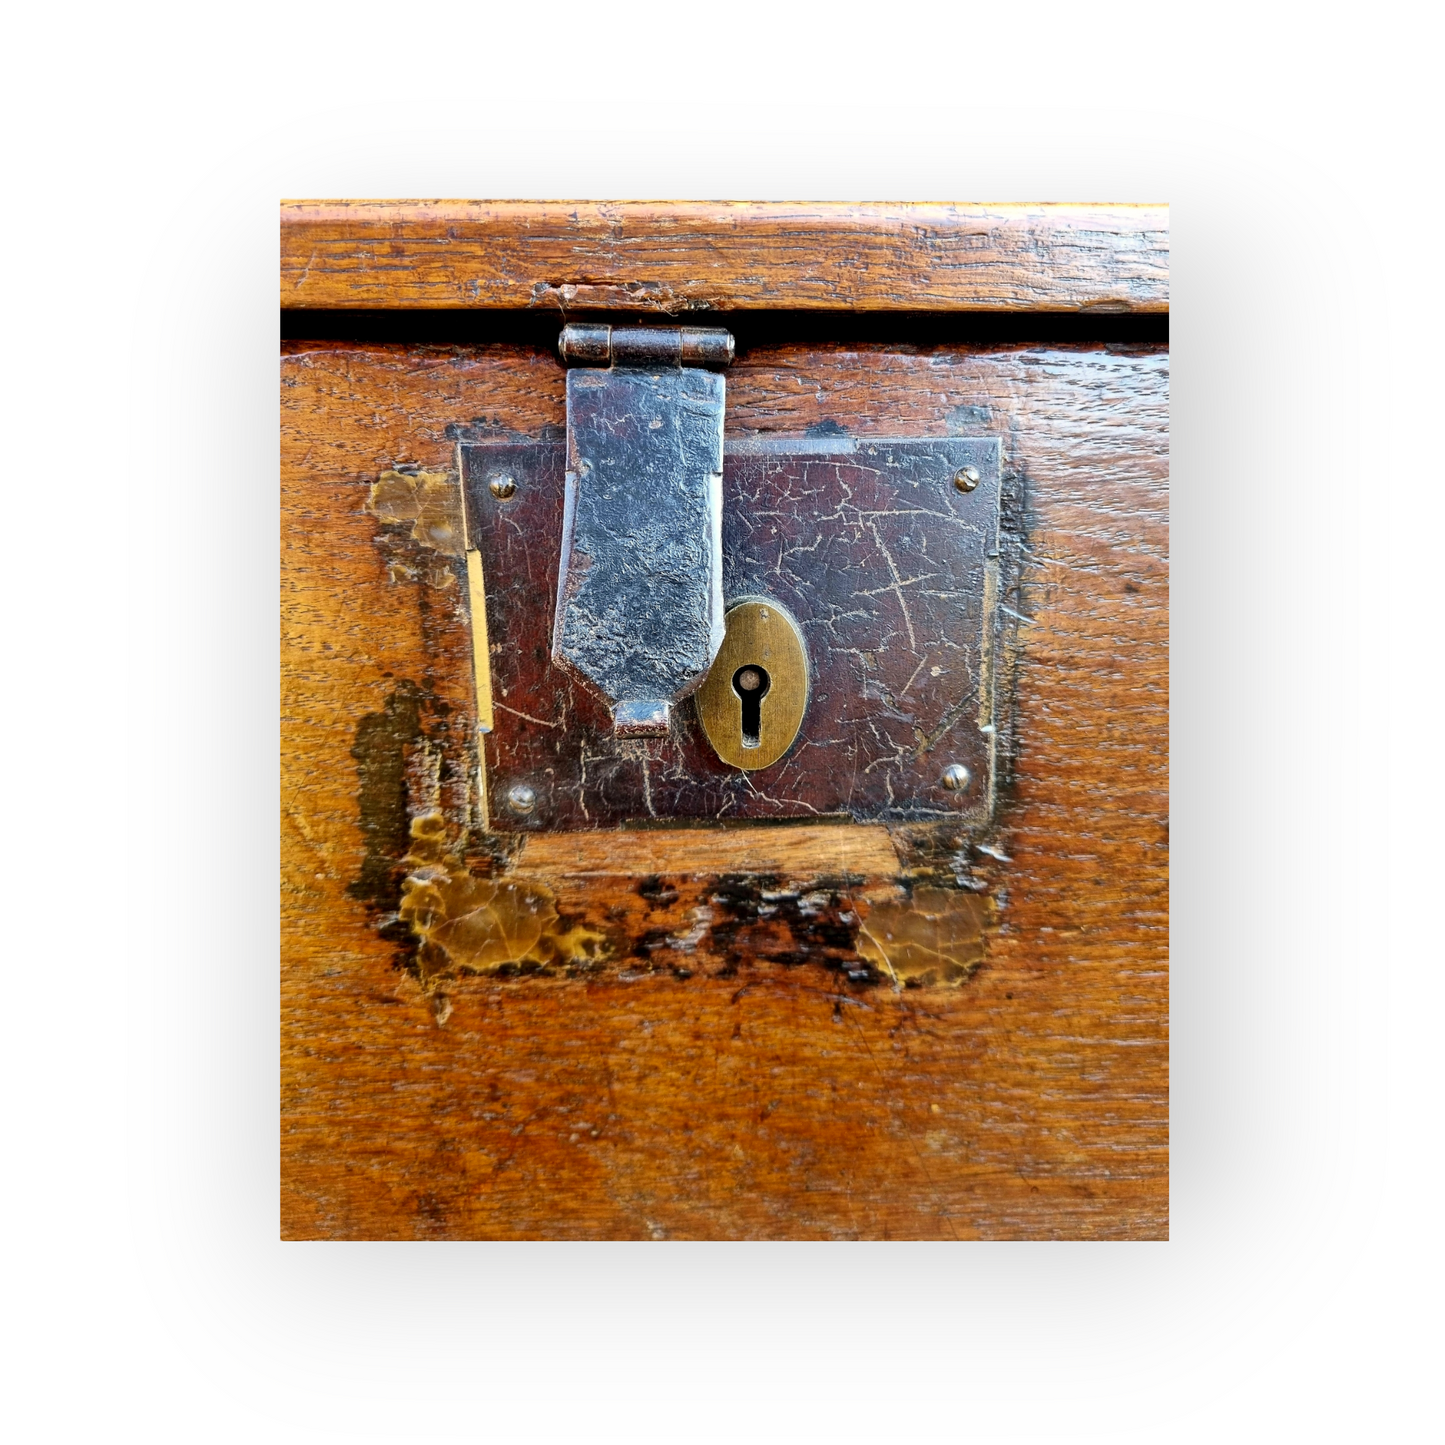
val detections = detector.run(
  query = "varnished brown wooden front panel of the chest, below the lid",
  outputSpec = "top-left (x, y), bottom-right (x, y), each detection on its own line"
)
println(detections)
top-left (282, 332), bottom-right (1168, 1238)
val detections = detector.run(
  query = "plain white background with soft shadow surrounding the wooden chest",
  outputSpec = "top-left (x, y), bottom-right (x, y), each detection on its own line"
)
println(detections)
top-left (0, 0), bottom-right (1442, 1442)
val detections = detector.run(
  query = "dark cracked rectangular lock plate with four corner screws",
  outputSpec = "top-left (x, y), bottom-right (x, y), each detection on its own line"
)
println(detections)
top-left (461, 436), bottom-right (1001, 831)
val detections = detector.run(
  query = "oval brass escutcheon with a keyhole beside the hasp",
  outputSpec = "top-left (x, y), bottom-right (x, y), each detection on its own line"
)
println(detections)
top-left (695, 597), bottom-right (808, 772)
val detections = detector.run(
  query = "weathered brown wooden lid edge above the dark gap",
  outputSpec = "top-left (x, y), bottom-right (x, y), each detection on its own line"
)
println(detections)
top-left (280, 201), bottom-right (1169, 315)
